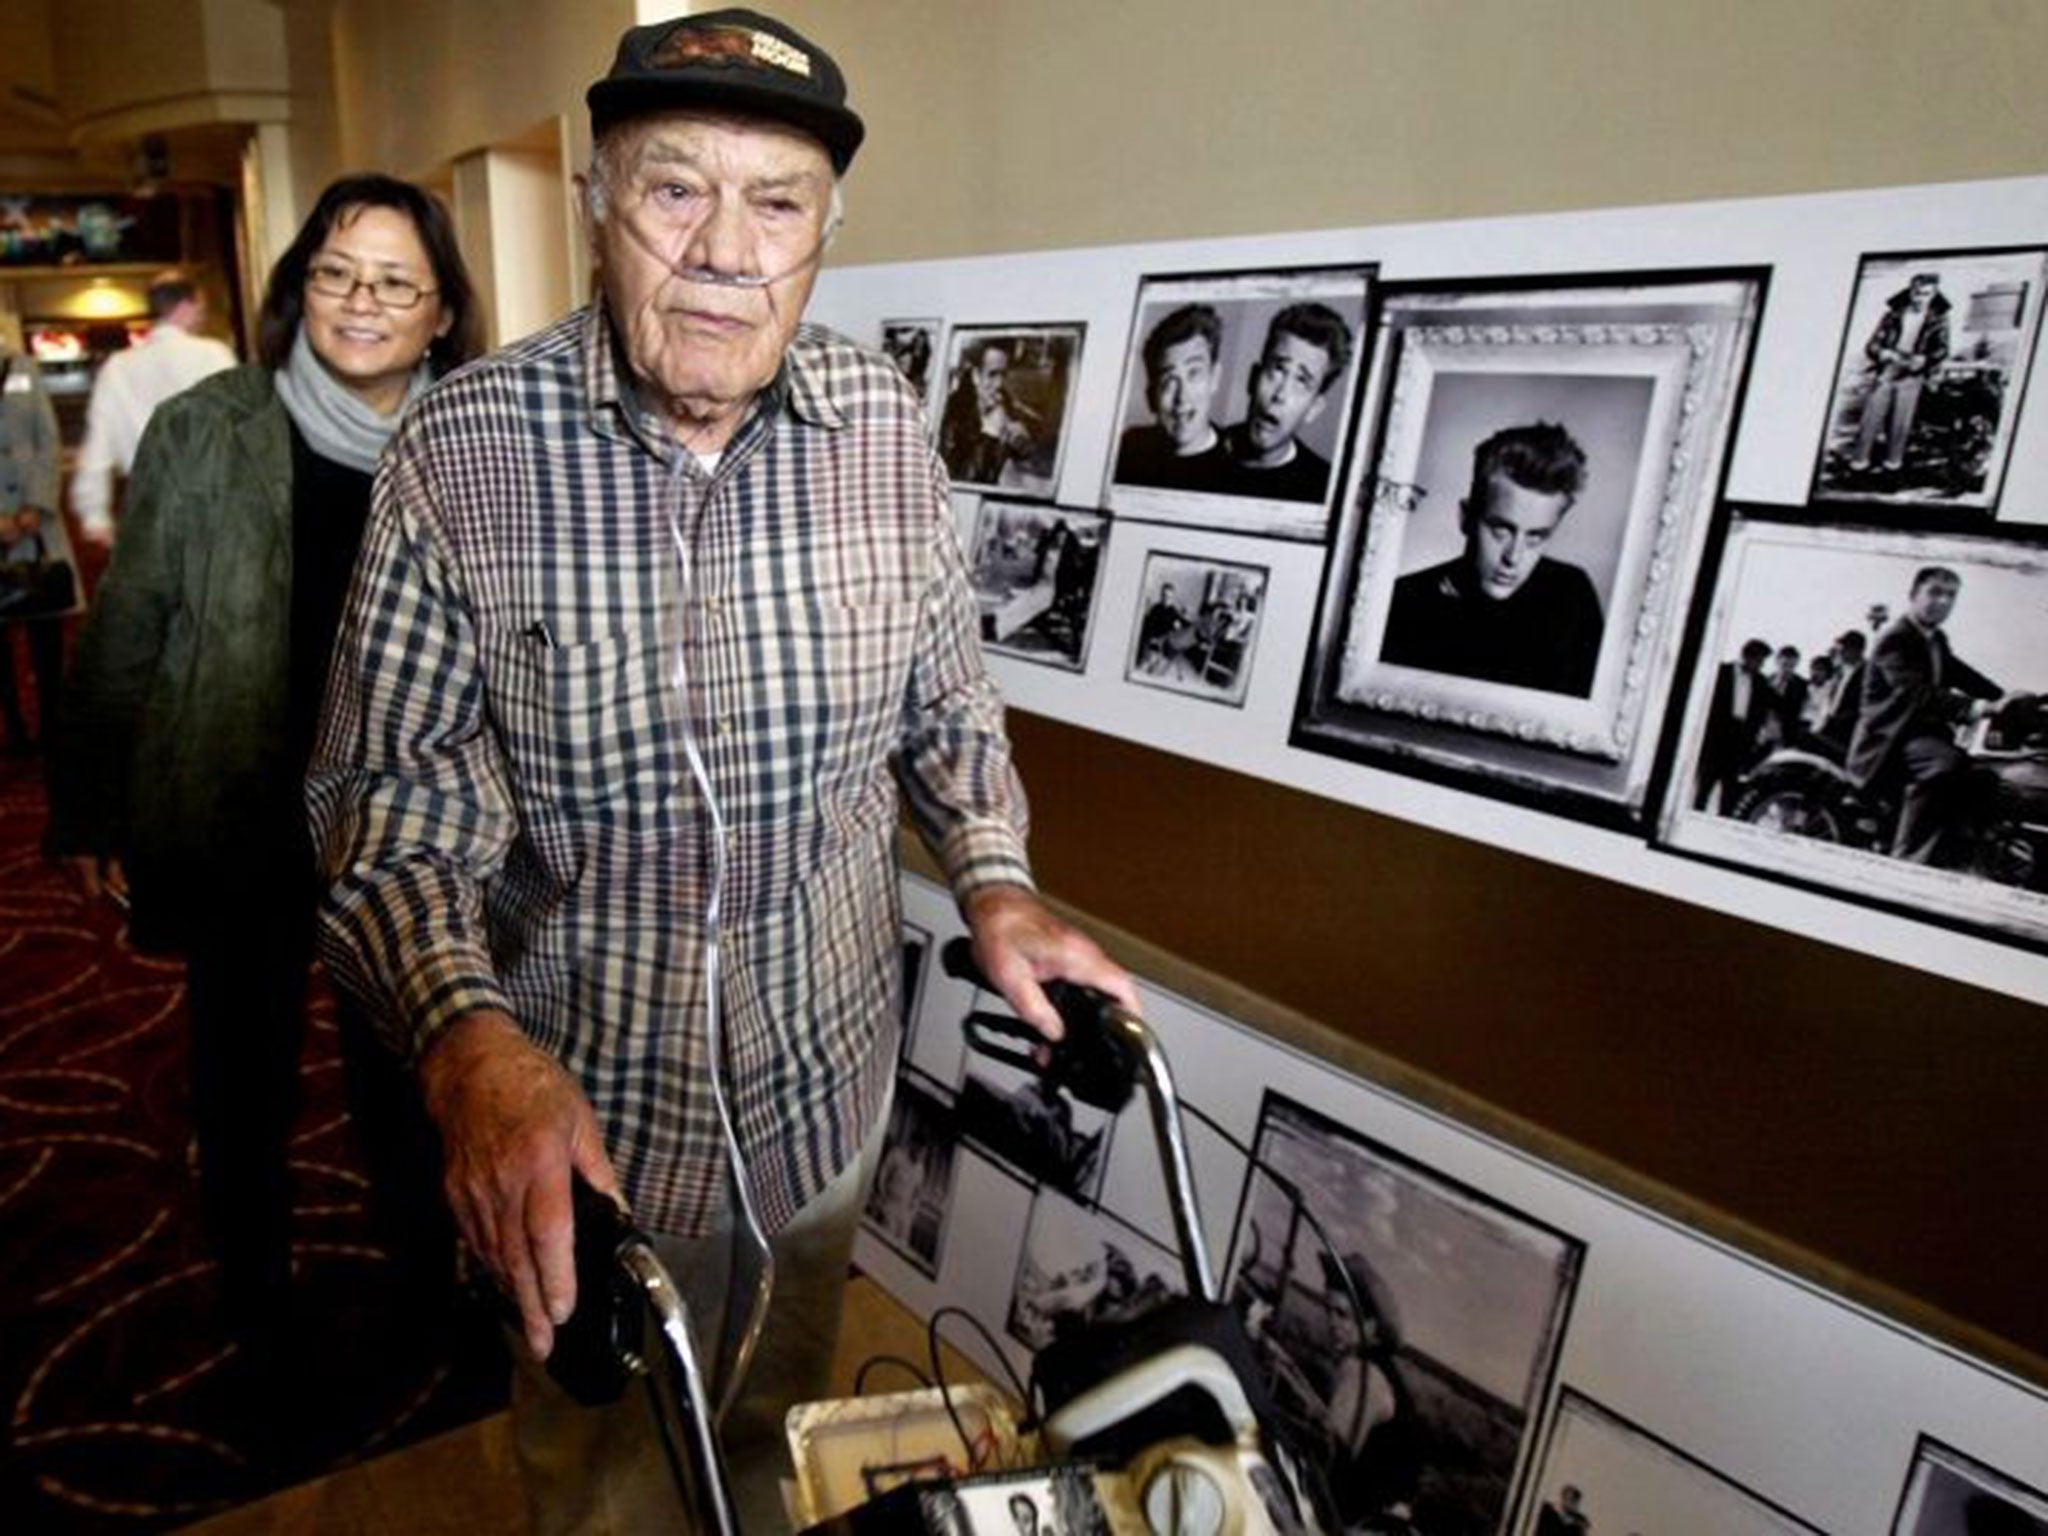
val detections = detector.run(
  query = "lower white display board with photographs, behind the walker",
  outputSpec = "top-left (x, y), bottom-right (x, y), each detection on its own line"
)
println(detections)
top-left (856, 877), bottom-right (2048, 1536)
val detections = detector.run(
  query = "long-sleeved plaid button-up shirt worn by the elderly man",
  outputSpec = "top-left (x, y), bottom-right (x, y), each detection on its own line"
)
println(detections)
top-left (307, 307), bottom-right (1030, 1235)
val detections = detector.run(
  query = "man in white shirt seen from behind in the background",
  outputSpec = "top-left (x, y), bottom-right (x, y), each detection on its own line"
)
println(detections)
top-left (72, 272), bottom-right (236, 549)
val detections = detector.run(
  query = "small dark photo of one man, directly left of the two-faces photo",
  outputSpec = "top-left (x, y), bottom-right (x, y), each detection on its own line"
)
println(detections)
top-left (938, 324), bottom-right (1087, 498)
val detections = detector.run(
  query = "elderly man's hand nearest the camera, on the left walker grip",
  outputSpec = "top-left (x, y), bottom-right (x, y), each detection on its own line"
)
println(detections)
top-left (420, 1010), bottom-right (618, 1360)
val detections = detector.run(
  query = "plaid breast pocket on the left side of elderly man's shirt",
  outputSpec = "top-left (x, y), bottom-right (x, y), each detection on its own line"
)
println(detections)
top-left (487, 633), bottom-right (676, 821)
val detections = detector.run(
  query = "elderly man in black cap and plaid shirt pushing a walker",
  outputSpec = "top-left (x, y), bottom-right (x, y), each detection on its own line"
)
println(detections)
top-left (309, 10), bottom-right (1137, 1530)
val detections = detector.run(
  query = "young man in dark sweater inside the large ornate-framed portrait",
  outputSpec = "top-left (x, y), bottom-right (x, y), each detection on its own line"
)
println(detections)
top-left (1380, 422), bottom-right (1606, 698)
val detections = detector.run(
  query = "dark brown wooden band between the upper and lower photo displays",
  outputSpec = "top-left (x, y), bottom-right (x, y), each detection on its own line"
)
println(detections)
top-left (1010, 713), bottom-right (2048, 1358)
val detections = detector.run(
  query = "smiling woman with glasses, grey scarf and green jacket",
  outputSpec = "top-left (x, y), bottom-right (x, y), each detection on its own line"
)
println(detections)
top-left (51, 176), bottom-right (479, 1370)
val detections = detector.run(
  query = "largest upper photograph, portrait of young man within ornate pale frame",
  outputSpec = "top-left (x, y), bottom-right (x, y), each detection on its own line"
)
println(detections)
top-left (1294, 272), bottom-right (1761, 825)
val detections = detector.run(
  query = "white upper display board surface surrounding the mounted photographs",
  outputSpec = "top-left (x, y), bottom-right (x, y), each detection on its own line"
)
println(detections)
top-left (811, 178), bottom-right (2048, 1001)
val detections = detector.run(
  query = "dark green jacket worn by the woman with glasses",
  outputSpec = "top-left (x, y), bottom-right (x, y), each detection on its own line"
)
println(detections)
top-left (51, 369), bottom-right (303, 948)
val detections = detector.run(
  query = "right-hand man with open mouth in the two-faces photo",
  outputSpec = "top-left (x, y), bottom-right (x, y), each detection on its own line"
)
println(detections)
top-left (1225, 303), bottom-right (1352, 502)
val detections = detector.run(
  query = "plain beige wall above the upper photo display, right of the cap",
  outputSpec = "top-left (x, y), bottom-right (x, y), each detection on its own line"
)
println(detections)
top-left (778, 0), bottom-right (2048, 262)
